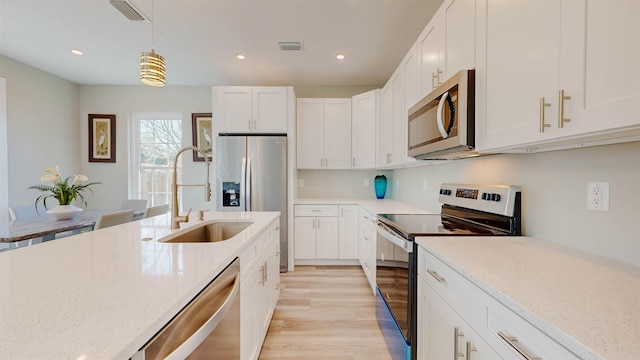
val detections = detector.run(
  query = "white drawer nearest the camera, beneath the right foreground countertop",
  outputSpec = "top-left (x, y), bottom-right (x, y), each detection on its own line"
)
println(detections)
top-left (471, 286), bottom-right (579, 360)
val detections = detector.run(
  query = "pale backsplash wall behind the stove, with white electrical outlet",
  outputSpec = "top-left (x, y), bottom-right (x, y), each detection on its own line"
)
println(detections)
top-left (392, 142), bottom-right (640, 266)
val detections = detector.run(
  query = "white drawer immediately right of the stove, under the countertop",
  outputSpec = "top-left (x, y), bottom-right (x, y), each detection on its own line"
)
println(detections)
top-left (418, 247), bottom-right (471, 321)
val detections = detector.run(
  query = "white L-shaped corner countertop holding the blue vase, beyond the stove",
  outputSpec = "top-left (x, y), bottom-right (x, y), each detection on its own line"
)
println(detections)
top-left (294, 198), bottom-right (440, 215)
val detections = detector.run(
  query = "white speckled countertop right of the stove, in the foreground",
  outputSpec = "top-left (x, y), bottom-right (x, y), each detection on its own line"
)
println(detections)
top-left (417, 237), bottom-right (640, 360)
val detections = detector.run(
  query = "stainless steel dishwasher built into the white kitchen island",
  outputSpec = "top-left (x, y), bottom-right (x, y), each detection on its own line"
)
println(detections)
top-left (131, 258), bottom-right (240, 360)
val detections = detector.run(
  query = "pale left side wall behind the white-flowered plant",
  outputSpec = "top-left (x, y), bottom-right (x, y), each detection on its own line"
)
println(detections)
top-left (0, 55), bottom-right (80, 211)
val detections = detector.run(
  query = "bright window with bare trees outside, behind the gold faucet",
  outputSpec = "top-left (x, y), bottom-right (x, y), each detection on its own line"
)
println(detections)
top-left (129, 113), bottom-right (182, 206)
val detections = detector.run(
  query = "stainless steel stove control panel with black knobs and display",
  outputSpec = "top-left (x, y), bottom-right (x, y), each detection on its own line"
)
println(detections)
top-left (439, 183), bottom-right (522, 216)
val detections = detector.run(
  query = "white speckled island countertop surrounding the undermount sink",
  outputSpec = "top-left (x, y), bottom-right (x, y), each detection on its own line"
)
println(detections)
top-left (0, 212), bottom-right (279, 360)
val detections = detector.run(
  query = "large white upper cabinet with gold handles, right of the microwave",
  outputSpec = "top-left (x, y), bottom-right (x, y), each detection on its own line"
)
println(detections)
top-left (476, 0), bottom-right (640, 152)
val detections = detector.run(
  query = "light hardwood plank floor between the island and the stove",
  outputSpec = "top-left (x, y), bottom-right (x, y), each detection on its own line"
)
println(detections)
top-left (259, 266), bottom-right (391, 360)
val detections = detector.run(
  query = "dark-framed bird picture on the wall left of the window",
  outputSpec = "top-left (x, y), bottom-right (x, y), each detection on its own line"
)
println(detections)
top-left (89, 114), bottom-right (116, 163)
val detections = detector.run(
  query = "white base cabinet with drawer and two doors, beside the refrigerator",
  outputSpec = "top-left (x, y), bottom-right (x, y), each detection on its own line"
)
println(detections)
top-left (294, 205), bottom-right (339, 260)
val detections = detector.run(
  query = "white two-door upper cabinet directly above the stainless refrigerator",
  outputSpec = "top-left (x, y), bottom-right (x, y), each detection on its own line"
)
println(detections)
top-left (213, 86), bottom-right (289, 133)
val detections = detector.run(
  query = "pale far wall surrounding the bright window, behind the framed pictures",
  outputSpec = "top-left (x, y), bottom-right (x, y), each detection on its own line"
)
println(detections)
top-left (79, 85), bottom-right (215, 212)
